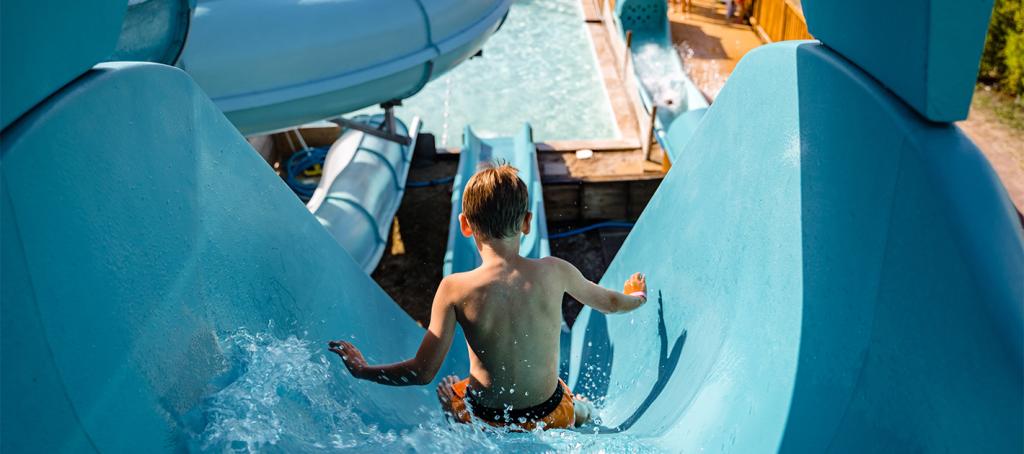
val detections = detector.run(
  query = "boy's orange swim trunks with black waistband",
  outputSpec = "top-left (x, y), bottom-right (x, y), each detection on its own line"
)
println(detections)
top-left (452, 378), bottom-right (575, 430)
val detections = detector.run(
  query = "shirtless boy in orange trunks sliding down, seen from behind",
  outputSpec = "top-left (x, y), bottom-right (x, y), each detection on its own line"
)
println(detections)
top-left (330, 165), bottom-right (647, 430)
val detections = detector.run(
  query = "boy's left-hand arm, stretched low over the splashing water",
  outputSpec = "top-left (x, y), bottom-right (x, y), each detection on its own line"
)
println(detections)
top-left (329, 279), bottom-right (456, 386)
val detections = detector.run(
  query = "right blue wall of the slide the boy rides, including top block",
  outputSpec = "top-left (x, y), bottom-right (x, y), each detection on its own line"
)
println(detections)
top-left (570, 1), bottom-right (1024, 452)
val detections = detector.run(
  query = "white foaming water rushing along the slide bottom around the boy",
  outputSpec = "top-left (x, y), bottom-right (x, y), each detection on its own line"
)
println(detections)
top-left (187, 329), bottom-right (652, 453)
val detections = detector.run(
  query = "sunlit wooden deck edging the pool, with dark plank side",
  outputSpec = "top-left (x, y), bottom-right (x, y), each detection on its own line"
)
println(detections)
top-left (538, 0), bottom-right (762, 222)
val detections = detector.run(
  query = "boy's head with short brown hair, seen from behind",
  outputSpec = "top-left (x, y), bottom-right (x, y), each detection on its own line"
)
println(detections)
top-left (462, 164), bottom-right (529, 240)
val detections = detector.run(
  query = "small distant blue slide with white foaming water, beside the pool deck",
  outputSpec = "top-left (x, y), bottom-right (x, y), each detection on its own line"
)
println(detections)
top-left (611, 0), bottom-right (708, 162)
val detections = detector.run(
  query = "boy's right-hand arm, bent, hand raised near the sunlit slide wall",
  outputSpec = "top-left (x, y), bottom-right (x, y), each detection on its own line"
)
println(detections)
top-left (552, 257), bottom-right (647, 314)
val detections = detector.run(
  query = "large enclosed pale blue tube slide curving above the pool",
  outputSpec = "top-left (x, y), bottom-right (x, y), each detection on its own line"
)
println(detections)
top-left (178, 0), bottom-right (511, 134)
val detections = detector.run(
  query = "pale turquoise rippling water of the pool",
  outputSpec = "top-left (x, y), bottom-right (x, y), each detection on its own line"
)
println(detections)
top-left (360, 0), bottom-right (618, 147)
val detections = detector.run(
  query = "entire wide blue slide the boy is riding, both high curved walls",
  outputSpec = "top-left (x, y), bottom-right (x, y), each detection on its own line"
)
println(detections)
top-left (0, 0), bottom-right (1024, 452)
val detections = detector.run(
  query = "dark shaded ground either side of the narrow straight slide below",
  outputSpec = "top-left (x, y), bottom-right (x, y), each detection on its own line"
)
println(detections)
top-left (373, 158), bottom-right (628, 326)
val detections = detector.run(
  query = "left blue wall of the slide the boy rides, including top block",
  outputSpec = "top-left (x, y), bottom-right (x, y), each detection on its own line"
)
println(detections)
top-left (0, 1), bottom-right (465, 452)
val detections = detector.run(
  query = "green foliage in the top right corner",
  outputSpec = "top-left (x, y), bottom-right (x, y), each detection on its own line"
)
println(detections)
top-left (978, 0), bottom-right (1024, 95)
